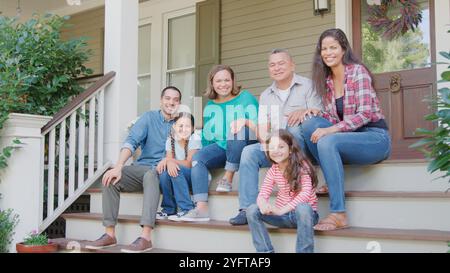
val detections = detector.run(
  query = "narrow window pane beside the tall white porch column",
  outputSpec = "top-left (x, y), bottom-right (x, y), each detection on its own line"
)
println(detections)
top-left (137, 24), bottom-right (151, 115)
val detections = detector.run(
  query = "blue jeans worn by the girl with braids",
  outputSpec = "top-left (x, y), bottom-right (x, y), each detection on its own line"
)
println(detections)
top-left (159, 165), bottom-right (194, 212)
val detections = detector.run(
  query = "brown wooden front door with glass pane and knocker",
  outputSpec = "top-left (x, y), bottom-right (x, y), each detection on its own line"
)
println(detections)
top-left (352, 0), bottom-right (436, 159)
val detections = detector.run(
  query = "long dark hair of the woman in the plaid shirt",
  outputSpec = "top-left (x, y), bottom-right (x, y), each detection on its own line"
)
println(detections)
top-left (312, 28), bottom-right (375, 99)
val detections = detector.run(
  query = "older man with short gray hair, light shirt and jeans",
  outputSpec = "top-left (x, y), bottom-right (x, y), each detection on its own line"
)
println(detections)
top-left (230, 49), bottom-right (323, 225)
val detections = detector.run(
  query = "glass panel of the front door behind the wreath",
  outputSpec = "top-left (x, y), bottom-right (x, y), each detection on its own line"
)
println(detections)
top-left (361, 0), bottom-right (431, 73)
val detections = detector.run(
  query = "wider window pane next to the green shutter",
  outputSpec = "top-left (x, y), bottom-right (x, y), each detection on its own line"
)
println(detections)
top-left (165, 11), bottom-right (195, 111)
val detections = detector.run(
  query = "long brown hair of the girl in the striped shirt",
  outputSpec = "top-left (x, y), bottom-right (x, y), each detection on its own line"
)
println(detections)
top-left (266, 129), bottom-right (318, 193)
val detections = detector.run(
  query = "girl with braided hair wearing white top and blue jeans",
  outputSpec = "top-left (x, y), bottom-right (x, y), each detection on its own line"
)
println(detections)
top-left (156, 112), bottom-right (202, 221)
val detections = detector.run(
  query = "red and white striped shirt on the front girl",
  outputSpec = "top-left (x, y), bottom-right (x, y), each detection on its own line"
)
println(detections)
top-left (258, 164), bottom-right (318, 211)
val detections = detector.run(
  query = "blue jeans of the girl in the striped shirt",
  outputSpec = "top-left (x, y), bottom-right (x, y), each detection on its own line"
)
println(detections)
top-left (247, 203), bottom-right (319, 253)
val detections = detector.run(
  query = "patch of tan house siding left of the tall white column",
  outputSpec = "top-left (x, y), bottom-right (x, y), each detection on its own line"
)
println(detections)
top-left (61, 7), bottom-right (105, 74)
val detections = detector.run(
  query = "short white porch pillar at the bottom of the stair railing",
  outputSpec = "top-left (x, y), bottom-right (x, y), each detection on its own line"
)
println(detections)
top-left (0, 114), bottom-right (51, 252)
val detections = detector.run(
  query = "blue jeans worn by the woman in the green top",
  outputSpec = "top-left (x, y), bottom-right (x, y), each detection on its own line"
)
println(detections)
top-left (191, 127), bottom-right (256, 202)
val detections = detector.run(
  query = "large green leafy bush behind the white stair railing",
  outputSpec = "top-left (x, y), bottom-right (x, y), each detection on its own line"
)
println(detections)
top-left (0, 14), bottom-right (92, 172)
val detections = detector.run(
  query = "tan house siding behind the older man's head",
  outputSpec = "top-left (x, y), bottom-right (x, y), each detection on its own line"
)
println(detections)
top-left (220, 0), bottom-right (335, 95)
